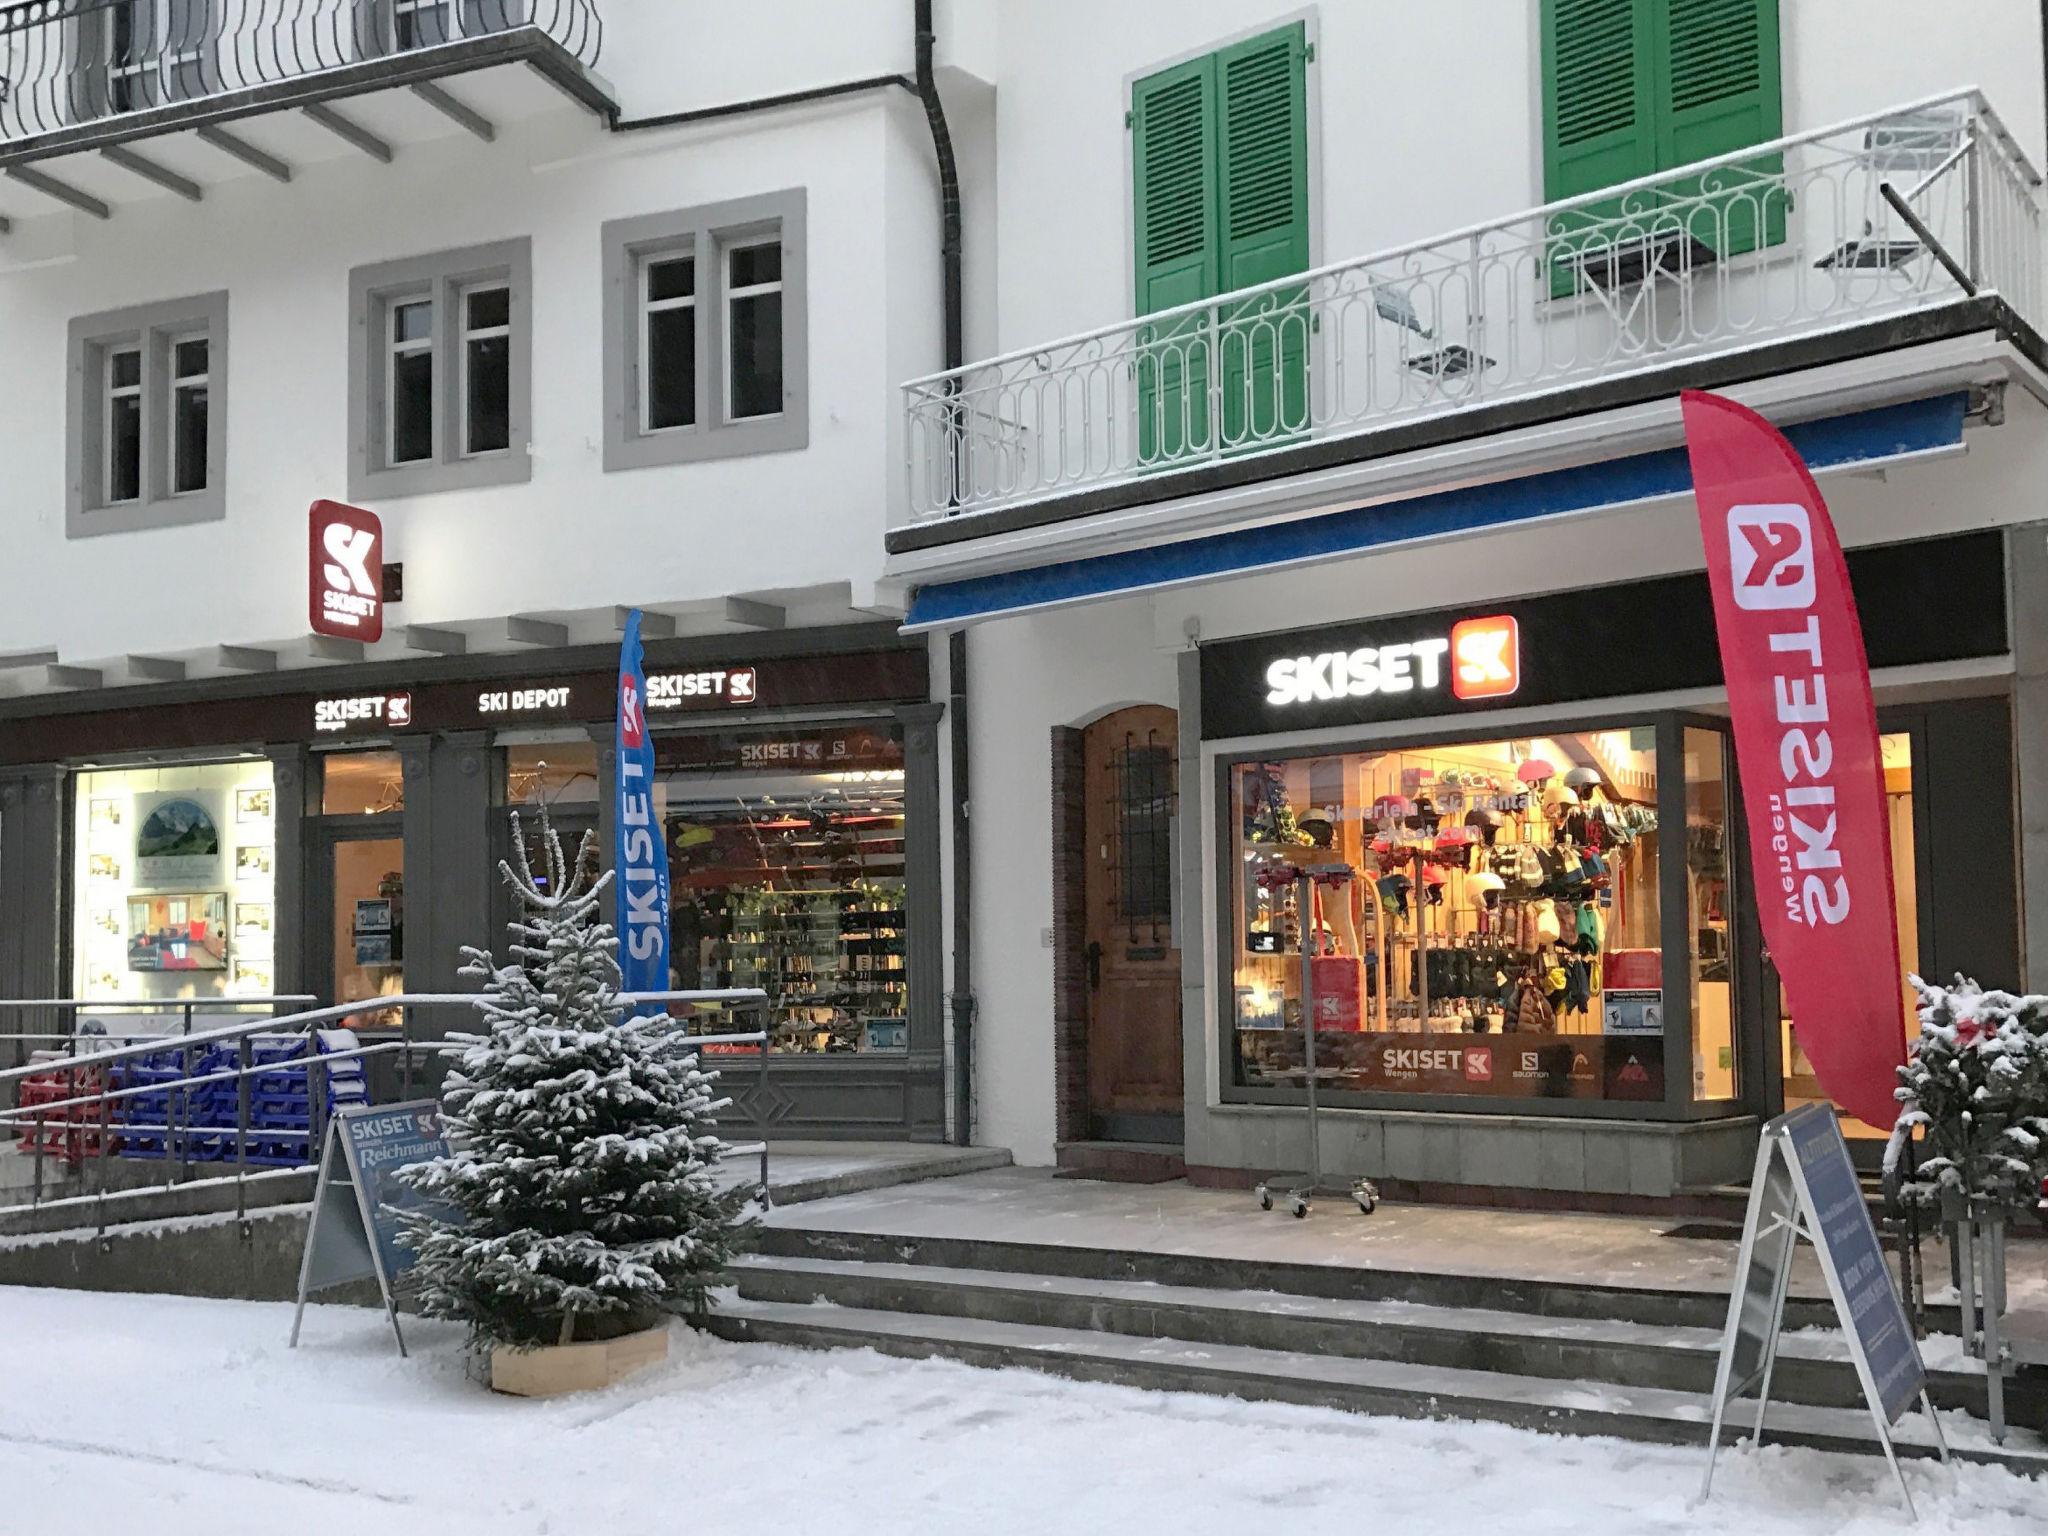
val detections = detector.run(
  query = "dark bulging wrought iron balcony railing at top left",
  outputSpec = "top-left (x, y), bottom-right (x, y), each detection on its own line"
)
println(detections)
top-left (0, 0), bottom-right (604, 145)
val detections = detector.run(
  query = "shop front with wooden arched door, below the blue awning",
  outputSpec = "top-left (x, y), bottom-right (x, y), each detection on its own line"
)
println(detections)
top-left (911, 372), bottom-right (2048, 1208)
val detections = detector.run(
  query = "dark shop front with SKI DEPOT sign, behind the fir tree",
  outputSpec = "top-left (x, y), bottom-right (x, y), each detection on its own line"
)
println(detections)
top-left (0, 625), bottom-right (944, 1141)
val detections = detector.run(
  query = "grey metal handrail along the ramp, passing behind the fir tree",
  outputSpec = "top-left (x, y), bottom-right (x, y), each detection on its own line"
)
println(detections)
top-left (0, 987), bottom-right (772, 1231)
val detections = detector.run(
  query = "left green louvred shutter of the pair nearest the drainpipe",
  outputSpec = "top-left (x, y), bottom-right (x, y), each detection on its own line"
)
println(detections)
top-left (1130, 57), bottom-right (1219, 463)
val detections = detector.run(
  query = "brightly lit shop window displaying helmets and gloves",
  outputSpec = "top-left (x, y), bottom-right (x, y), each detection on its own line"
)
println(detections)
top-left (1231, 727), bottom-right (1671, 1102)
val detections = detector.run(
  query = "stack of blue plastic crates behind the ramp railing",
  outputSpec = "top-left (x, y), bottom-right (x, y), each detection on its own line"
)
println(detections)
top-left (117, 1030), bottom-right (369, 1167)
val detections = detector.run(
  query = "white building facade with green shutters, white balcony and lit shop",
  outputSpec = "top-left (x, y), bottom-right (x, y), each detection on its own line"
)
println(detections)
top-left (909, 0), bottom-right (2048, 1206)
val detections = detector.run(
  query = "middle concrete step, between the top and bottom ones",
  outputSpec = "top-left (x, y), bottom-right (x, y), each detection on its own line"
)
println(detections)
top-left (733, 1255), bottom-right (2048, 1423)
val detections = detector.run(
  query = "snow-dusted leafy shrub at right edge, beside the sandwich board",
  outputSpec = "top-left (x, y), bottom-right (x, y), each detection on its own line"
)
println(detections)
top-left (1892, 977), bottom-right (2048, 1210)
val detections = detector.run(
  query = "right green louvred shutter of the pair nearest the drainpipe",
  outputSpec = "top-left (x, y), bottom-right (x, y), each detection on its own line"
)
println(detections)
top-left (1217, 23), bottom-right (1309, 446)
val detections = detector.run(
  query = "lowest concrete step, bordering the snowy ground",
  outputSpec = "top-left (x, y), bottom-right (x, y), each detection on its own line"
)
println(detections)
top-left (711, 1296), bottom-right (2048, 1473)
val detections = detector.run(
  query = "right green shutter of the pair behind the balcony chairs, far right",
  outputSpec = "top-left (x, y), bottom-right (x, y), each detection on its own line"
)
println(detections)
top-left (1651, 0), bottom-right (1786, 256)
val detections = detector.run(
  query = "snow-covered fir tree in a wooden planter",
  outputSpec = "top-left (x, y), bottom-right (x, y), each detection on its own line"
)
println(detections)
top-left (408, 813), bottom-right (752, 1346)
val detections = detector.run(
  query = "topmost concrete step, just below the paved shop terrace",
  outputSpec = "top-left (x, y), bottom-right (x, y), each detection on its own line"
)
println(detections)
top-left (754, 1210), bottom-right (1875, 1331)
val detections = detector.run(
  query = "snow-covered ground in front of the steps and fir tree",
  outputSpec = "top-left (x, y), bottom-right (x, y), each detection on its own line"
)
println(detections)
top-left (0, 1288), bottom-right (2048, 1536)
